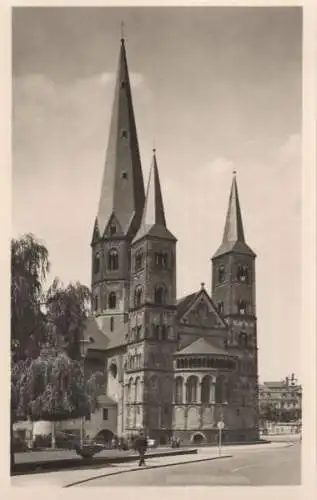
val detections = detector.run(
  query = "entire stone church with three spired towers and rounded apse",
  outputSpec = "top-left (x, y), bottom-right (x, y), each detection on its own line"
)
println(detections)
top-left (80, 39), bottom-right (258, 444)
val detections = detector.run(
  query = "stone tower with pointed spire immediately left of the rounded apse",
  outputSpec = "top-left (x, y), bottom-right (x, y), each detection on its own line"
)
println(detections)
top-left (125, 150), bottom-right (177, 442)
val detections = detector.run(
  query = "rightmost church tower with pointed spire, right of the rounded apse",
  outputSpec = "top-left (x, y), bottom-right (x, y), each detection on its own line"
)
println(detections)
top-left (212, 172), bottom-right (258, 441)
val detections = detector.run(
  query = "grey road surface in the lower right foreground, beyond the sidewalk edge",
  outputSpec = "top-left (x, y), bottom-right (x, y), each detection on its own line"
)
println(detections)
top-left (78, 443), bottom-right (301, 487)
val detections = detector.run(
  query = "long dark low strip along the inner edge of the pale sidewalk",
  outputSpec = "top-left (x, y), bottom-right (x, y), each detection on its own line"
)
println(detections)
top-left (11, 448), bottom-right (197, 476)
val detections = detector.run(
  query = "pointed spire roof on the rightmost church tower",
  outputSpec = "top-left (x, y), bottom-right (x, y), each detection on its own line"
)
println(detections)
top-left (213, 172), bottom-right (255, 258)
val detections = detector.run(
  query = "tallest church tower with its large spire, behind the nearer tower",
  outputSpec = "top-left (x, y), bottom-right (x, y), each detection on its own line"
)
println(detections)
top-left (91, 38), bottom-right (145, 337)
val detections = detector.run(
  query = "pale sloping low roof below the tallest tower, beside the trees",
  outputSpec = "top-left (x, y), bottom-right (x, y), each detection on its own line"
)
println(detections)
top-left (85, 316), bottom-right (125, 351)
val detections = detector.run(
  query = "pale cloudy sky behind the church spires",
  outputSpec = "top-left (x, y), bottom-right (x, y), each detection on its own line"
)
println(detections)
top-left (12, 7), bottom-right (302, 380)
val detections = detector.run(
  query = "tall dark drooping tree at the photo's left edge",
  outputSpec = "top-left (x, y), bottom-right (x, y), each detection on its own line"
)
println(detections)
top-left (11, 234), bottom-right (50, 361)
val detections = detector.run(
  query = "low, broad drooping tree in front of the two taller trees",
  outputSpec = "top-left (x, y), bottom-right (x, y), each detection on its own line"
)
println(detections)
top-left (11, 345), bottom-right (104, 467)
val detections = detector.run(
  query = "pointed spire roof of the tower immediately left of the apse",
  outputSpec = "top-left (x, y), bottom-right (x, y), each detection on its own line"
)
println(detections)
top-left (133, 149), bottom-right (176, 242)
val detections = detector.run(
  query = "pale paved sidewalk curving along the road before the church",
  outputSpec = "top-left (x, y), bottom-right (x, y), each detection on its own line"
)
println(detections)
top-left (11, 443), bottom-right (287, 488)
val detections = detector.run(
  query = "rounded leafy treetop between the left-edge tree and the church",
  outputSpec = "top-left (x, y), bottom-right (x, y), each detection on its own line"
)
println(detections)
top-left (46, 278), bottom-right (91, 360)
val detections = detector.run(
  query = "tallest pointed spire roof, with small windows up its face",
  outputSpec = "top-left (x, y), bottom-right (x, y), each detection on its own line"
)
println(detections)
top-left (95, 38), bottom-right (145, 237)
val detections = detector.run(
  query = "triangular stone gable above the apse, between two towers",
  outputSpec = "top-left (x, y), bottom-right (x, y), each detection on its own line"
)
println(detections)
top-left (177, 288), bottom-right (228, 329)
